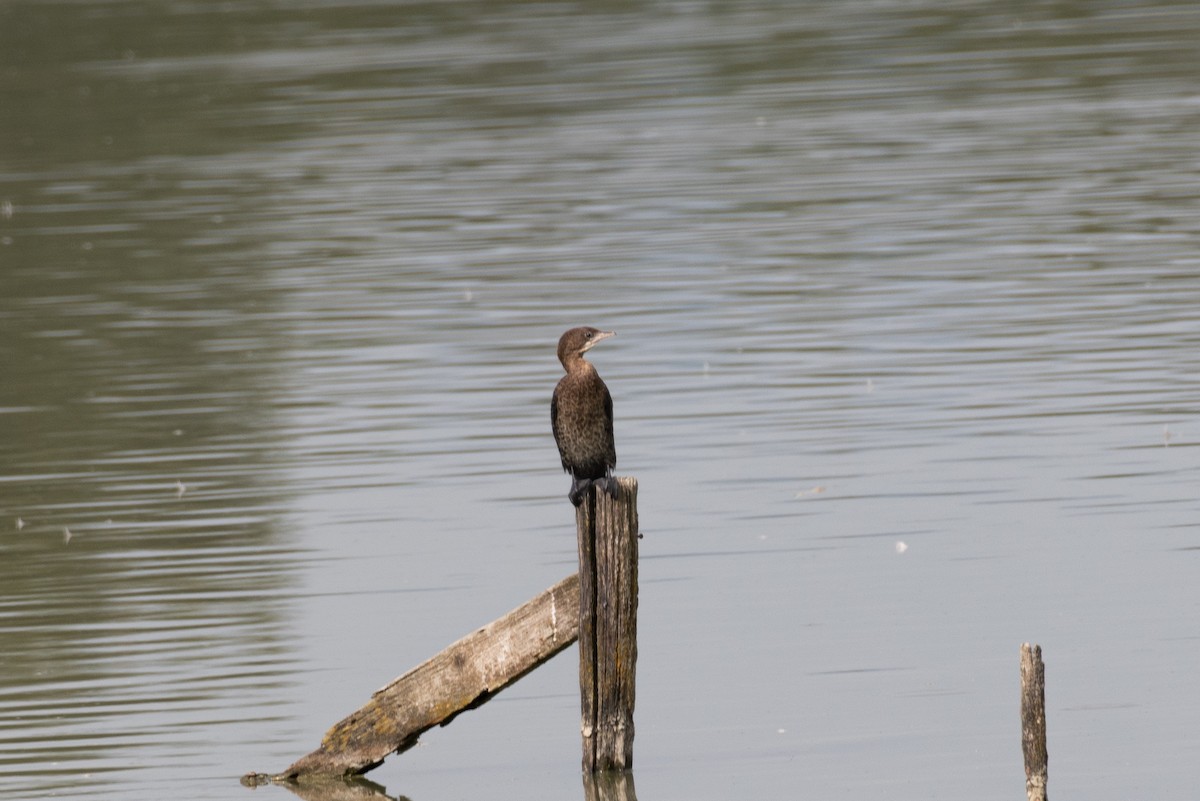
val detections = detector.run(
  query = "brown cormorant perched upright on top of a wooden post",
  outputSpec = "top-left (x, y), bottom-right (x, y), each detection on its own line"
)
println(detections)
top-left (550, 326), bottom-right (617, 506)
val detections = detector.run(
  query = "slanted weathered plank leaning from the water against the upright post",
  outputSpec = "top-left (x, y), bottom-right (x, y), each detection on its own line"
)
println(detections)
top-left (280, 574), bottom-right (580, 781)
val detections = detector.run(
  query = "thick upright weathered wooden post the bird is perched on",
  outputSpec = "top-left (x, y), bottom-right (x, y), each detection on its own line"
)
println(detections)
top-left (575, 477), bottom-right (637, 773)
